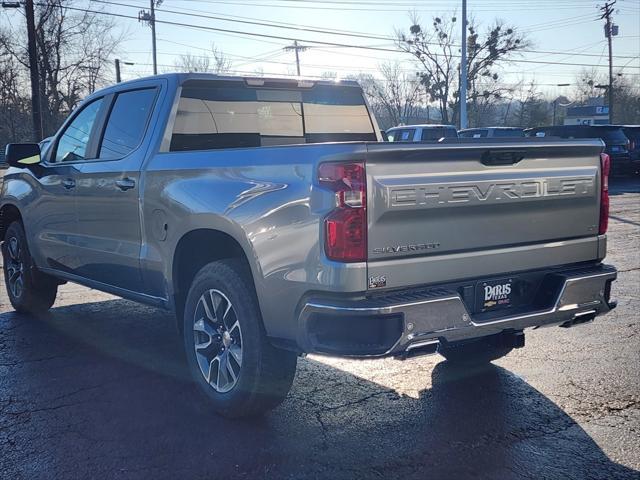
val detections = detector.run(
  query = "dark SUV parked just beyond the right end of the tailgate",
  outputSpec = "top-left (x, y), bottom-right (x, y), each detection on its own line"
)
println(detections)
top-left (525, 125), bottom-right (633, 175)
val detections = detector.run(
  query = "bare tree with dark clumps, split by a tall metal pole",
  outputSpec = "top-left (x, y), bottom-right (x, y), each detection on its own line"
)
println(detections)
top-left (397, 15), bottom-right (528, 123)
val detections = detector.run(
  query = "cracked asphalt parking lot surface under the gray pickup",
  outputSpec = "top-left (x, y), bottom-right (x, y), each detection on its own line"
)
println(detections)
top-left (0, 180), bottom-right (640, 480)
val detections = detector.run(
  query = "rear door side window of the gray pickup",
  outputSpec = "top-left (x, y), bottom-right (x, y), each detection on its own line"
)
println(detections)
top-left (99, 88), bottom-right (156, 159)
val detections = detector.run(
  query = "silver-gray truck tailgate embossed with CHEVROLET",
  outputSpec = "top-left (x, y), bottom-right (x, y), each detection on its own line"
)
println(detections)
top-left (366, 139), bottom-right (603, 288)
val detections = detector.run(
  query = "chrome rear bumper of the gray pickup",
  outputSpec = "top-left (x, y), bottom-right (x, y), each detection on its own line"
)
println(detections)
top-left (298, 265), bottom-right (617, 357)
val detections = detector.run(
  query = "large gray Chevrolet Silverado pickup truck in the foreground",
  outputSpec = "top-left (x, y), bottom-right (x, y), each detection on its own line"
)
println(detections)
top-left (0, 74), bottom-right (616, 416)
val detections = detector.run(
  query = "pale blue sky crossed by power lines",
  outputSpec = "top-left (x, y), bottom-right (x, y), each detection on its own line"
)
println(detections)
top-left (1, 0), bottom-right (640, 96)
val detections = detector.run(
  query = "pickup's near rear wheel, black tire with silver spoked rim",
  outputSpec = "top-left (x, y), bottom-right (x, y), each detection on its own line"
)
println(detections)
top-left (183, 259), bottom-right (297, 418)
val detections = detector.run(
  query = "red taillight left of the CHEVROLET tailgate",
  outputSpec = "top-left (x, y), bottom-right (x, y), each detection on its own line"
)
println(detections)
top-left (318, 162), bottom-right (367, 262)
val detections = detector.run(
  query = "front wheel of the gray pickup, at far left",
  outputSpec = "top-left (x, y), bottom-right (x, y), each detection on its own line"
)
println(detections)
top-left (2, 222), bottom-right (58, 315)
